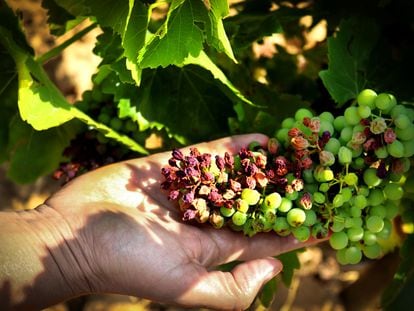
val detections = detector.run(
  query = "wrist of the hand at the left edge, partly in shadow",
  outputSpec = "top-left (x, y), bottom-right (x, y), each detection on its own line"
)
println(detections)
top-left (0, 205), bottom-right (90, 310)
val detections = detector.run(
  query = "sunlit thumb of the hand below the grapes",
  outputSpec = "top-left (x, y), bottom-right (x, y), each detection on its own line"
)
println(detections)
top-left (178, 257), bottom-right (282, 310)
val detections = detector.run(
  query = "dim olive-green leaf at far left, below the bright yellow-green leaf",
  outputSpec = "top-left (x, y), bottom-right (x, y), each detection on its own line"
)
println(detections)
top-left (7, 116), bottom-right (78, 183)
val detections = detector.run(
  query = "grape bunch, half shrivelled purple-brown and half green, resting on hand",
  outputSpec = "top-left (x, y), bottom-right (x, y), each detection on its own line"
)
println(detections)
top-left (162, 89), bottom-right (414, 264)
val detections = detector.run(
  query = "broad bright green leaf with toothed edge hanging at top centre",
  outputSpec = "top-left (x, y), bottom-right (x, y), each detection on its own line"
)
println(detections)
top-left (138, 1), bottom-right (204, 68)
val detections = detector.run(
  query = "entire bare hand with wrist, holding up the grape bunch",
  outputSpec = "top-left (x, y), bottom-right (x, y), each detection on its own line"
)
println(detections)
top-left (0, 134), bottom-right (326, 310)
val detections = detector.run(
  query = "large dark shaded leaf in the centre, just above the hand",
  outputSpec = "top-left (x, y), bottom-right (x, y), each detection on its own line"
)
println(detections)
top-left (137, 65), bottom-right (234, 142)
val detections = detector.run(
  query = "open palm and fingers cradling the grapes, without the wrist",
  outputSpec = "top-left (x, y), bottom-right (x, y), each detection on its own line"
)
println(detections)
top-left (17, 135), bottom-right (326, 309)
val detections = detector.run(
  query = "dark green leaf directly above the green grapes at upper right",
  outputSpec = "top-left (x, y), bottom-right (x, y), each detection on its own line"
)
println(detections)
top-left (319, 17), bottom-right (379, 106)
